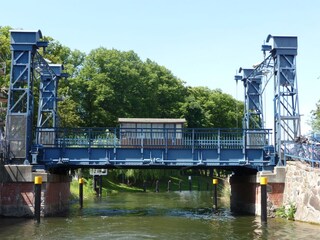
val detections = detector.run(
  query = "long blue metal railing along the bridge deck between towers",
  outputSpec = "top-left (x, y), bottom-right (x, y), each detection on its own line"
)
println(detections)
top-left (35, 128), bottom-right (271, 149)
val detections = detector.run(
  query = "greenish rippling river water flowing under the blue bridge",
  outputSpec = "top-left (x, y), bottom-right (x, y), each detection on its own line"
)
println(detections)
top-left (0, 191), bottom-right (320, 240)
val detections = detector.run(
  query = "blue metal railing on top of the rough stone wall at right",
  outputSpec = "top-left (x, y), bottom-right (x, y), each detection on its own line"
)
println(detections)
top-left (284, 143), bottom-right (320, 167)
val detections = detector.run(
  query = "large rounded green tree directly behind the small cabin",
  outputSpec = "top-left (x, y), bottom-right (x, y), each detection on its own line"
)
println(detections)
top-left (73, 47), bottom-right (186, 127)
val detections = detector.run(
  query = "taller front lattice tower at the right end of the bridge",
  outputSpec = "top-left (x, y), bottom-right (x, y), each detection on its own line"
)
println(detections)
top-left (267, 35), bottom-right (301, 164)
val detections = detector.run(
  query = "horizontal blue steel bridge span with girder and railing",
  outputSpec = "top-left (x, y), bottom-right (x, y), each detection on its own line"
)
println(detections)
top-left (33, 128), bottom-right (275, 168)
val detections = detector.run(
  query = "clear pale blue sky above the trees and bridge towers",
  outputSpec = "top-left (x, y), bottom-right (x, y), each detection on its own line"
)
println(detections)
top-left (0, 0), bottom-right (320, 132)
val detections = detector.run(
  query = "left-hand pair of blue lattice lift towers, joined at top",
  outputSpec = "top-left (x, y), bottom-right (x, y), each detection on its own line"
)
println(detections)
top-left (6, 30), bottom-right (66, 161)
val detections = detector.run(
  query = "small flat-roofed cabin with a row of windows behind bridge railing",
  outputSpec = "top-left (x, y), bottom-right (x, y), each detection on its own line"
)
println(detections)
top-left (118, 118), bottom-right (186, 148)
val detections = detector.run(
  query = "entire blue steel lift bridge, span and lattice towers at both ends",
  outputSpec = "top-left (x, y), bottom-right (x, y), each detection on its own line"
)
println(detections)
top-left (3, 30), bottom-right (300, 170)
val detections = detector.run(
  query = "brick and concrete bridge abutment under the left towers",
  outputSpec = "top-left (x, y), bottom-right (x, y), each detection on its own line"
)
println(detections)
top-left (0, 165), bottom-right (70, 217)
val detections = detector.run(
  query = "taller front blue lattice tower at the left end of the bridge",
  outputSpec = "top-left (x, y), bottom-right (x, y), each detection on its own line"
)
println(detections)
top-left (6, 30), bottom-right (46, 159)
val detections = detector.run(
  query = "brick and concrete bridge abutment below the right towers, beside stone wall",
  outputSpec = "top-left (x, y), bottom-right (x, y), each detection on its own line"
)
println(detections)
top-left (230, 167), bottom-right (286, 217)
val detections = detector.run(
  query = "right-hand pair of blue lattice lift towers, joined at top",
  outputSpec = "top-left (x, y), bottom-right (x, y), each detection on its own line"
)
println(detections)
top-left (235, 35), bottom-right (301, 165)
